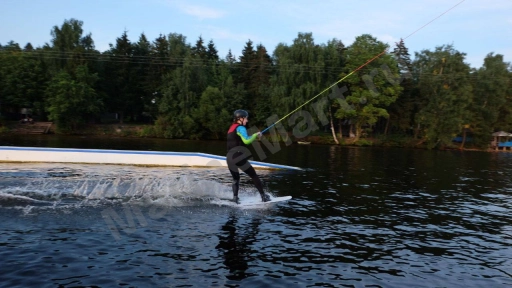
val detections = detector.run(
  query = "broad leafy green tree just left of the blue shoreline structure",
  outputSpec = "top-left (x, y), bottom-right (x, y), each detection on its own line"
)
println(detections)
top-left (414, 45), bottom-right (473, 148)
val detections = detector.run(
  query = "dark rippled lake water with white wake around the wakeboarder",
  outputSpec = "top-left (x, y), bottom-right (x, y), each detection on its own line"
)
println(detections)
top-left (0, 135), bottom-right (512, 287)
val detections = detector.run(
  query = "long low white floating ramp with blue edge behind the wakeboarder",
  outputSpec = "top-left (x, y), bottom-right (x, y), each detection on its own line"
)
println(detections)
top-left (0, 146), bottom-right (302, 170)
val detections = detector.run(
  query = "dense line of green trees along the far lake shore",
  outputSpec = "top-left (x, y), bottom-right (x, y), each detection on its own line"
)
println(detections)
top-left (0, 19), bottom-right (512, 148)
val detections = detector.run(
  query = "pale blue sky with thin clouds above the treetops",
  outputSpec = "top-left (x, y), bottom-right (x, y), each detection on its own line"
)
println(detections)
top-left (0, 0), bottom-right (512, 68)
